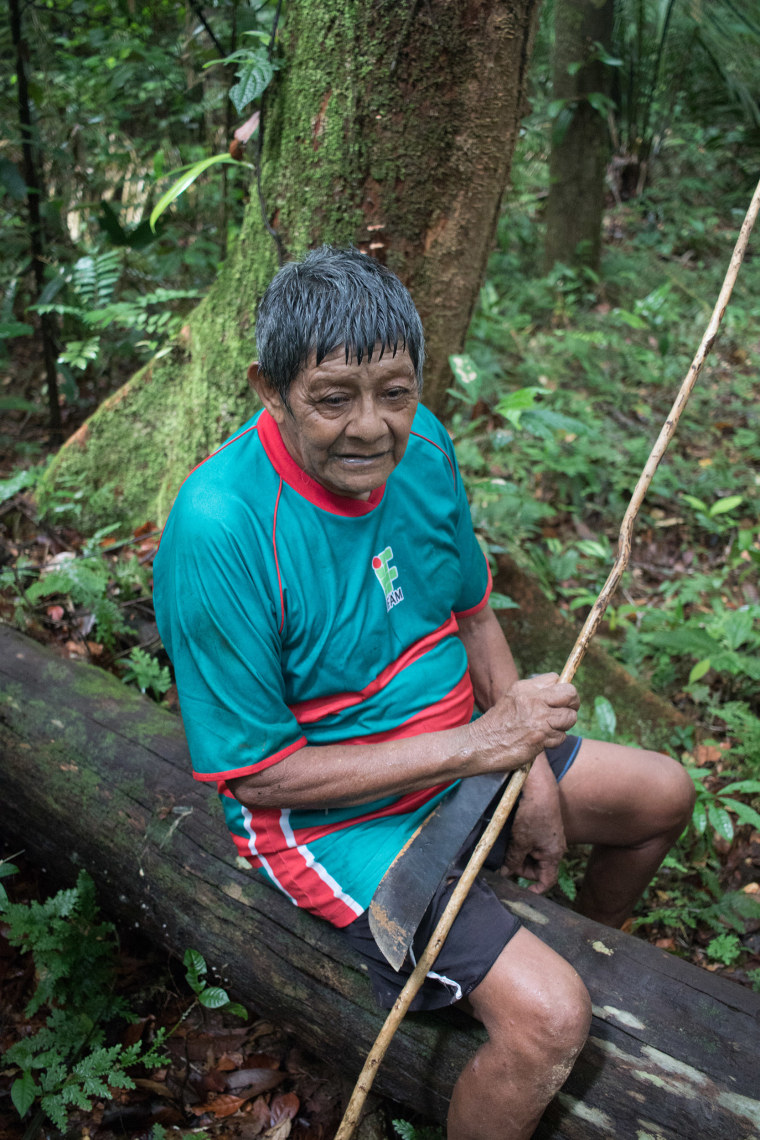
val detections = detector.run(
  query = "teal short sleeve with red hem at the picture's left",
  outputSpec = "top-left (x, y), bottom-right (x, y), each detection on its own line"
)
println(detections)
top-left (154, 485), bottom-right (305, 781)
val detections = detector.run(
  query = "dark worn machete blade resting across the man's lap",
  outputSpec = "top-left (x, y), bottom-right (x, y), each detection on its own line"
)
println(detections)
top-left (369, 772), bottom-right (508, 971)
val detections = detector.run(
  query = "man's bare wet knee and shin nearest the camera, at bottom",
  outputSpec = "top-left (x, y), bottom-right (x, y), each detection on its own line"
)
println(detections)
top-left (448, 929), bottom-right (591, 1140)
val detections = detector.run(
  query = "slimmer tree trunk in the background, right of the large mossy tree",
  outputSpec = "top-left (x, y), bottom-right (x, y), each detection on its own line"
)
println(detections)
top-left (545, 0), bottom-right (614, 270)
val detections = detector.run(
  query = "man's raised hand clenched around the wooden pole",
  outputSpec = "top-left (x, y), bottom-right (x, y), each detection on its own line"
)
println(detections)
top-left (472, 673), bottom-right (580, 771)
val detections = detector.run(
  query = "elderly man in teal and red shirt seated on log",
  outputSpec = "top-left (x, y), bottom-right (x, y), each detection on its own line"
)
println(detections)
top-left (155, 247), bottom-right (692, 1140)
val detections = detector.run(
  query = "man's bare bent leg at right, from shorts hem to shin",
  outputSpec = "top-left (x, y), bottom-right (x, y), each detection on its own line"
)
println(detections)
top-left (559, 740), bottom-right (694, 927)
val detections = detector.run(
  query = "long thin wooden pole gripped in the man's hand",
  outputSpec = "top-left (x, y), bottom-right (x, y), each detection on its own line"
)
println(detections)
top-left (335, 182), bottom-right (760, 1140)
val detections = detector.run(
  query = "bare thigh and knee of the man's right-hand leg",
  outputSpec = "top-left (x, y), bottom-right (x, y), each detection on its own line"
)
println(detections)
top-left (558, 740), bottom-right (693, 847)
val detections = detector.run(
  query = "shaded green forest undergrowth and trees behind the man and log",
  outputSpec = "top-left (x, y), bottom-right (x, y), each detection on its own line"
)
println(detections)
top-left (0, 0), bottom-right (760, 1140)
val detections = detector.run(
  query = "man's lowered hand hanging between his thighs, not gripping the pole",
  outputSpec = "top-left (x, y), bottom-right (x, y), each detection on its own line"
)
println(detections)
top-left (504, 754), bottom-right (566, 895)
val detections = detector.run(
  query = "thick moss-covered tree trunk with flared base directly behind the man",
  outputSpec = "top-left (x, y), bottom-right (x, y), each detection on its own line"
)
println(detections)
top-left (40, 0), bottom-right (538, 526)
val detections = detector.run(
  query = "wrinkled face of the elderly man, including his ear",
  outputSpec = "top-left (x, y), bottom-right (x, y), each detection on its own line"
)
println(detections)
top-left (260, 348), bottom-right (418, 499)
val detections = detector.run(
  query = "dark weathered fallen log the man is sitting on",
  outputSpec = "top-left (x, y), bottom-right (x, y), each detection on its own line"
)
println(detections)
top-left (0, 627), bottom-right (760, 1140)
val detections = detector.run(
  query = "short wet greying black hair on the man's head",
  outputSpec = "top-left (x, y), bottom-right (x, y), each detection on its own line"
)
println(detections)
top-left (256, 245), bottom-right (425, 404)
